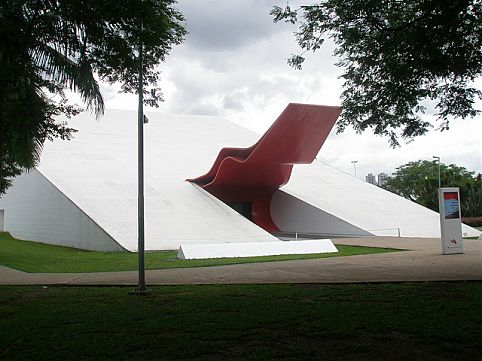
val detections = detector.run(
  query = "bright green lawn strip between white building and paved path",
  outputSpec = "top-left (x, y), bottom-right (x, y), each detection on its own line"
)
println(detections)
top-left (0, 232), bottom-right (397, 273)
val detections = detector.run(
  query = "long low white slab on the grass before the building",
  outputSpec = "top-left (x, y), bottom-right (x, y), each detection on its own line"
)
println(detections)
top-left (177, 239), bottom-right (338, 259)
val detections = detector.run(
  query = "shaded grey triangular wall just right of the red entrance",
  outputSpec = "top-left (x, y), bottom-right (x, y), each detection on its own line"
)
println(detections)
top-left (271, 190), bottom-right (372, 237)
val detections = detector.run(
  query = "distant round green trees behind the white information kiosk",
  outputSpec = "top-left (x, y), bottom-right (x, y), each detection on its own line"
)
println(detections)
top-left (384, 160), bottom-right (482, 217)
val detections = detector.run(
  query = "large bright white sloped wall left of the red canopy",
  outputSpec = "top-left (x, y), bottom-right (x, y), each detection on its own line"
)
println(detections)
top-left (34, 111), bottom-right (276, 251)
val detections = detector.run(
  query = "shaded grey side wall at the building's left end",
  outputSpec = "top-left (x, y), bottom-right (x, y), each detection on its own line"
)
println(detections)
top-left (0, 170), bottom-right (123, 251)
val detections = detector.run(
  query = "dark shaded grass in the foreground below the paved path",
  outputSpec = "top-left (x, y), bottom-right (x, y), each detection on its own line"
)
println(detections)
top-left (0, 282), bottom-right (482, 361)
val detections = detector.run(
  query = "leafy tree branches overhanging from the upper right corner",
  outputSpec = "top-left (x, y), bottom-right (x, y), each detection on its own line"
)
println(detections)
top-left (271, 0), bottom-right (482, 146)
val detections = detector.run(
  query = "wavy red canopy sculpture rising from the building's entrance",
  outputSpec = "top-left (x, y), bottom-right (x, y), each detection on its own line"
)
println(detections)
top-left (188, 103), bottom-right (341, 232)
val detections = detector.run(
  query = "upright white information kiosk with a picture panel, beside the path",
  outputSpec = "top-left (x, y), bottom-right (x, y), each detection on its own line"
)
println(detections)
top-left (438, 187), bottom-right (464, 254)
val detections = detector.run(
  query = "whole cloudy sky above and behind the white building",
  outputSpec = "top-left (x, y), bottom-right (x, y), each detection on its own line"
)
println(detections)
top-left (102, 0), bottom-right (482, 179)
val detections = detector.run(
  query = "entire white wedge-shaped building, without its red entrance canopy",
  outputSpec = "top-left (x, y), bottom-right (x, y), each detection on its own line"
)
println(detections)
top-left (0, 111), bottom-right (479, 251)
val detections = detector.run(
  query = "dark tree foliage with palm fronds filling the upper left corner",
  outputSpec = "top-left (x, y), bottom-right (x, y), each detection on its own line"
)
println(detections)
top-left (0, 0), bottom-right (186, 195)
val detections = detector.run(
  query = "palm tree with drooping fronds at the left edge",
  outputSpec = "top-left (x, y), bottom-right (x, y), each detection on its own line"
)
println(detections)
top-left (0, 1), bottom-right (104, 195)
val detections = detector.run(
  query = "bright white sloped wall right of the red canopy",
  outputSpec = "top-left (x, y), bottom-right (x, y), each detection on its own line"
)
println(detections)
top-left (282, 162), bottom-right (479, 237)
